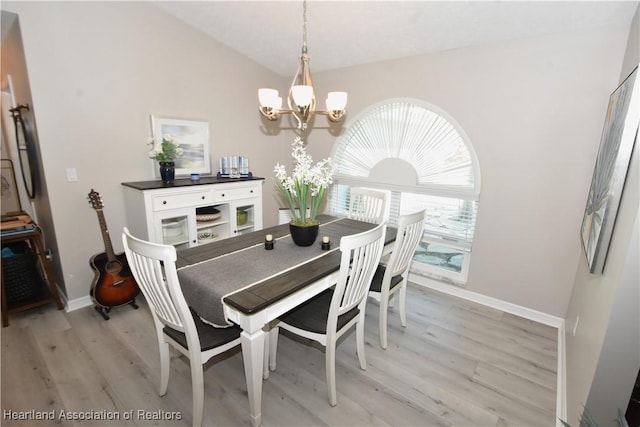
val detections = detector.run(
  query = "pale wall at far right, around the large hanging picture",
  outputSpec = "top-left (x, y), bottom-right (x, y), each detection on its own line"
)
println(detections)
top-left (566, 5), bottom-right (640, 425)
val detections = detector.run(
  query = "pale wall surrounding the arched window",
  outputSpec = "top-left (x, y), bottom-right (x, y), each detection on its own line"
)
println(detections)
top-left (310, 27), bottom-right (628, 317)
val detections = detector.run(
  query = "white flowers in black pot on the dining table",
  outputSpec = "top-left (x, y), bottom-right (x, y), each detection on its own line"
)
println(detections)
top-left (274, 137), bottom-right (333, 246)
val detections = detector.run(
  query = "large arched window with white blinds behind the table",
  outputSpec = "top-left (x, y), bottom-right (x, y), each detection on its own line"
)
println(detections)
top-left (329, 99), bottom-right (480, 284)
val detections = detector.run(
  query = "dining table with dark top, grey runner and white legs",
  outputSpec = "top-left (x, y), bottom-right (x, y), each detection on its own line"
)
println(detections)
top-left (176, 215), bottom-right (397, 427)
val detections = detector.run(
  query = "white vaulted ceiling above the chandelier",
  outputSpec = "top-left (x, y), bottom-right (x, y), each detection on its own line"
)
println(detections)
top-left (153, 0), bottom-right (639, 76)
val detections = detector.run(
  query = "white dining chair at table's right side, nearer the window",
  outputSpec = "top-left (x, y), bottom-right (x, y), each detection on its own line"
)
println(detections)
top-left (369, 209), bottom-right (426, 349)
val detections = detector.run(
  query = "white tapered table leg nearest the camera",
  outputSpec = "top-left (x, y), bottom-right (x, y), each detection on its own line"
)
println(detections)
top-left (240, 329), bottom-right (264, 427)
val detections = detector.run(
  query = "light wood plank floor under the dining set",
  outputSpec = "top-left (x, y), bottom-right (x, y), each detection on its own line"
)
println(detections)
top-left (1, 287), bottom-right (557, 426)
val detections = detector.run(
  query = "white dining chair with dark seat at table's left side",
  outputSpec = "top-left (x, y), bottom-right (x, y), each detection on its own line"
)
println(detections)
top-left (122, 227), bottom-right (240, 426)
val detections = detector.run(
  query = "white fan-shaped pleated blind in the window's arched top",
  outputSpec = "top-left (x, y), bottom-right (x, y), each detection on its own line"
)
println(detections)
top-left (332, 100), bottom-right (479, 193)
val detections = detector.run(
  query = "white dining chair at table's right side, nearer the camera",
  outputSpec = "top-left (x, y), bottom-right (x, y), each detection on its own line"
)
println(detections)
top-left (269, 223), bottom-right (386, 406)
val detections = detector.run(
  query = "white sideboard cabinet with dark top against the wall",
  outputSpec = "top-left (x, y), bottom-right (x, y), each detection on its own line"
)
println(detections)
top-left (122, 177), bottom-right (264, 248)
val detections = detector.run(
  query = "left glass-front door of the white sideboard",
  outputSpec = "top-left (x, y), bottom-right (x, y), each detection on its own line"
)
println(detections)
top-left (155, 209), bottom-right (198, 249)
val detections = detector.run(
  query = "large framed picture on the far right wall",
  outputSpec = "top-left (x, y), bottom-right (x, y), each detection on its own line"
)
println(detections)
top-left (581, 67), bottom-right (640, 274)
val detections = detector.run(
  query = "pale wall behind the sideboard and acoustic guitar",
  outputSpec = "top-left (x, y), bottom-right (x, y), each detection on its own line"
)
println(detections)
top-left (2, 2), bottom-right (288, 300)
